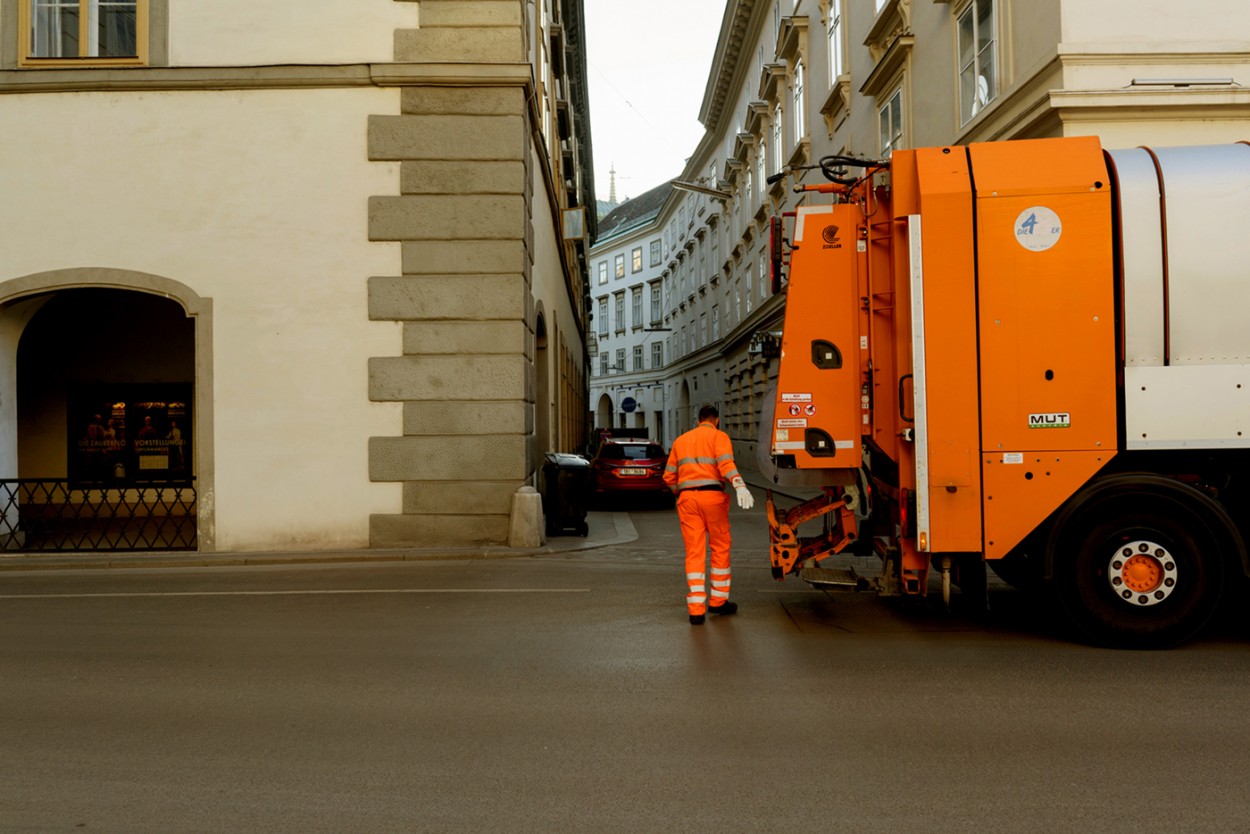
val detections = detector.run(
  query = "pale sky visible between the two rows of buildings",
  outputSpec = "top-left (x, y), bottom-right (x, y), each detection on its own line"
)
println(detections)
top-left (584, 0), bottom-right (726, 203)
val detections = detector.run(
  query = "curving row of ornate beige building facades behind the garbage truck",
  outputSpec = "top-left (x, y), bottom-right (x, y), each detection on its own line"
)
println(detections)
top-left (590, 0), bottom-right (1250, 466)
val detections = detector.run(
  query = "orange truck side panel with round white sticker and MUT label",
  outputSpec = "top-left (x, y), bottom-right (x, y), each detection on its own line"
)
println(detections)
top-left (969, 139), bottom-right (1116, 559)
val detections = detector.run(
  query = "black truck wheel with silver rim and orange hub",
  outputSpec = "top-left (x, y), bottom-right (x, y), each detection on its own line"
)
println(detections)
top-left (1054, 476), bottom-right (1225, 649)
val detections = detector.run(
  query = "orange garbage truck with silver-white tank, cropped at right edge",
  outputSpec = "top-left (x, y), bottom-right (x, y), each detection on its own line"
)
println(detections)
top-left (760, 138), bottom-right (1250, 648)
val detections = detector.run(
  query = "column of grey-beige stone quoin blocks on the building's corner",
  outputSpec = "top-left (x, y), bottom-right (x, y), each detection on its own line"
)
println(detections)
top-left (369, 0), bottom-right (535, 546)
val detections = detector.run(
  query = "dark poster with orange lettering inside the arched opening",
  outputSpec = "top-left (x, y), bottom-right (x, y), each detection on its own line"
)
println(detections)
top-left (66, 384), bottom-right (193, 485)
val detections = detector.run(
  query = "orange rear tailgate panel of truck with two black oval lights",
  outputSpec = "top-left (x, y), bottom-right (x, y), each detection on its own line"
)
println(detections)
top-left (773, 204), bottom-right (861, 470)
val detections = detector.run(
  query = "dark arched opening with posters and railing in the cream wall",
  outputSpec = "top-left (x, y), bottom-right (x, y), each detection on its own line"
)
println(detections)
top-left (0, 278), bottom-right (211, 550)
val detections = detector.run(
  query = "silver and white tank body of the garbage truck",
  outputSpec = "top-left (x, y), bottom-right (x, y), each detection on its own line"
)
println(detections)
top-left (1108, 144), bottom-right (1250, 450)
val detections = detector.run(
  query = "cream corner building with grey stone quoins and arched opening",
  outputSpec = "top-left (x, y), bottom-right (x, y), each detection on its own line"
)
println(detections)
top-left (0, 0), bottom-right (595, 550)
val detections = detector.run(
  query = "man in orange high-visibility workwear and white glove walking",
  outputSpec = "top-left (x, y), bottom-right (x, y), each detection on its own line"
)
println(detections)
top-left (664, 405), bottom-right (755, 625)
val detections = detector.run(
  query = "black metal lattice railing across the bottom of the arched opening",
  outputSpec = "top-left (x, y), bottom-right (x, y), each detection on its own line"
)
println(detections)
top-left (0, 478), bottom-right (196, 553)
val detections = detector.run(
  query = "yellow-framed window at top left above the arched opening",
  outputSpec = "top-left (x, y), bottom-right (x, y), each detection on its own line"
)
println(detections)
top-left (18, 0), bottom-right (149, 65)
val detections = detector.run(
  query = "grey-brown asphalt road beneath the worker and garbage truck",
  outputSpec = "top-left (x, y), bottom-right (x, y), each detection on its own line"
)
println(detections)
top-left (0, 506), bottom-right (1250, 834)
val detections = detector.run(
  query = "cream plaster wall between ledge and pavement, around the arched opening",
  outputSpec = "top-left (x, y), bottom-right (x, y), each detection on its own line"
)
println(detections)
top-left (0, 88), bottom-right (403, 550)
